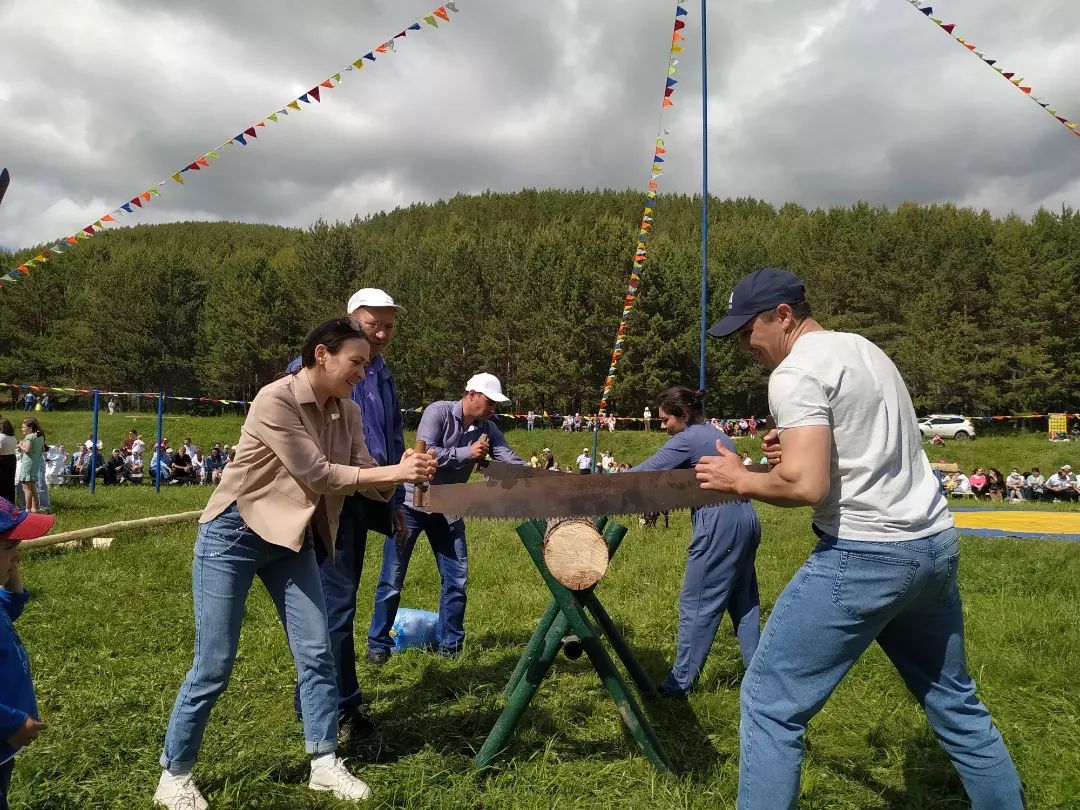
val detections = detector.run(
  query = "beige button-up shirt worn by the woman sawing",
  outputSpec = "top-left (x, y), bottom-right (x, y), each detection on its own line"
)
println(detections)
top-left (199, 368), bottom-right (394, 556)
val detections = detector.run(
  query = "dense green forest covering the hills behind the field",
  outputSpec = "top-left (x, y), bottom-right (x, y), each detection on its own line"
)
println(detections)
top-left (0, 190), bottom-right (1080, 415)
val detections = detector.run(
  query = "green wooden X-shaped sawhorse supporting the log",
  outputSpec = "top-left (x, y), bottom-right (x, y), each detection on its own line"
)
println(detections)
top-left (475, 517), bottom-right (672, 773)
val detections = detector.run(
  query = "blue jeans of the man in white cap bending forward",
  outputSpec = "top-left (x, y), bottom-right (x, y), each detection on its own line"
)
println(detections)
top-left (367, 505), bottom-right (469, 652)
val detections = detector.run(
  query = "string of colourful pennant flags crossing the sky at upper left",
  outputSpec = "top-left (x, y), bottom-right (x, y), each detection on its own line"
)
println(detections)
top-left (0, 0), bottom-right (458, 286)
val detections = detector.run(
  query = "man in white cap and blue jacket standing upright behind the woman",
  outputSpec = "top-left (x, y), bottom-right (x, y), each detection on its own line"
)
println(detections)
top-left (288, 287), bottom-right (406, 738)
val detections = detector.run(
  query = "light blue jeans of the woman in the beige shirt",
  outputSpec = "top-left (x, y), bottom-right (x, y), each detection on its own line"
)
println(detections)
top-left (161, 504), bottom-right (338, 774)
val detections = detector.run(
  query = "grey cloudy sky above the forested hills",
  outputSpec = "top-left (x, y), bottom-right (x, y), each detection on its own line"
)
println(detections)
top-left (0, 0), bottom-right (1080, 248)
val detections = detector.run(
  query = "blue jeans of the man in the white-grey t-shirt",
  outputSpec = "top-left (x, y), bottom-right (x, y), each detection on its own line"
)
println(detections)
top-left (739, 529), bottom-right (1023, 810)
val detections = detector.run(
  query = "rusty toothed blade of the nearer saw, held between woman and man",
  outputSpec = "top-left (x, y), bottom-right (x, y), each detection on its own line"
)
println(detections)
top-left (430, 470), bottom-right (742, 519)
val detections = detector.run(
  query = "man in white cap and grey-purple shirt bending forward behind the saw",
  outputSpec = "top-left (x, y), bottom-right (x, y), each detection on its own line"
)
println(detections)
top-left (367, 374), bottom-right (525, 663)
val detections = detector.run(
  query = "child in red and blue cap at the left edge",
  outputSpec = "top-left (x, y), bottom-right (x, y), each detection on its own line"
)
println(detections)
top-left (0, 498), bottom-right (56, 810)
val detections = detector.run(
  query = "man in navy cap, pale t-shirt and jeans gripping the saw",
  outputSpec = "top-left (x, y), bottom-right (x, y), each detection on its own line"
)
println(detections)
top-left (697, 268), bottom-right (1023, 810)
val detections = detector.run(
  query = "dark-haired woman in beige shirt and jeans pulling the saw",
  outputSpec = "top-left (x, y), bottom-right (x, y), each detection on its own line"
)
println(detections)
top-left (154, 318), bottom-right (435, 810)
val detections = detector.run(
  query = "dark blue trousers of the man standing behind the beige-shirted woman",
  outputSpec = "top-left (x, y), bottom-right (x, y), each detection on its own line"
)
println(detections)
top-left (295, 495), bottom-right (367, 716)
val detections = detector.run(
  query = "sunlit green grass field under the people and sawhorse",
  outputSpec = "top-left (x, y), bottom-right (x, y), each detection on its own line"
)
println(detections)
top-left (13, 421), bottom-right (1080, 810)
